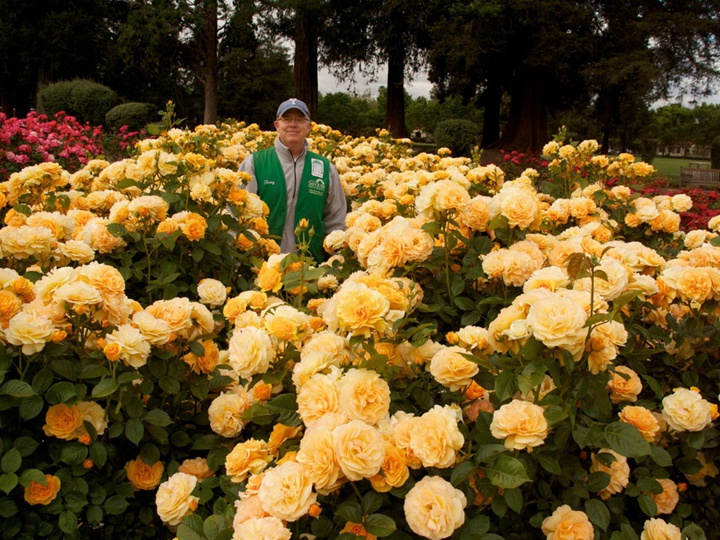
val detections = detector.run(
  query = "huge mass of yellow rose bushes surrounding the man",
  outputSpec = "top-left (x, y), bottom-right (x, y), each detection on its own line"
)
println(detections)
top-left (0, 115), bottom-right (720, 540)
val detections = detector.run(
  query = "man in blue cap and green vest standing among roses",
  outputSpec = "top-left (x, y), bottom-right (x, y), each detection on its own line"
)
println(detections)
top-left (240, 98), bottom-right (347, 262)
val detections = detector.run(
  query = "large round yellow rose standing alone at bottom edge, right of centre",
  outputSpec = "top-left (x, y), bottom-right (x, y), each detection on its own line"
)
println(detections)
top-left (403, 476), bottom-right (467, 540)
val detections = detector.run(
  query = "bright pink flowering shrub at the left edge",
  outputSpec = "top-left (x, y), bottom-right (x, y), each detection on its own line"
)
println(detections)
top-left (0, 112), bottom-right (103, 177)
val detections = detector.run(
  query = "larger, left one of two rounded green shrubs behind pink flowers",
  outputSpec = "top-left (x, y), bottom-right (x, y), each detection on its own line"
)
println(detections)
top-left (38, 79), bottom-right (120, 125)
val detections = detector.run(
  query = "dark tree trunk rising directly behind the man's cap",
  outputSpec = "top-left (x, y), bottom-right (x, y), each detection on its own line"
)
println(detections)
top-left (294, 8), bottom-right (318, 118)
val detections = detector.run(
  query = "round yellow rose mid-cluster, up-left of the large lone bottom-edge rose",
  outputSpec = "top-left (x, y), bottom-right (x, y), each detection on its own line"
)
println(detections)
top-left (333, 420), bottom-right (385, 481)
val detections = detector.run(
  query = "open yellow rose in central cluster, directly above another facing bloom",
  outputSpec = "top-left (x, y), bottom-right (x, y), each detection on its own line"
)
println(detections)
top-left (338, 369), bottom-right (390, 424)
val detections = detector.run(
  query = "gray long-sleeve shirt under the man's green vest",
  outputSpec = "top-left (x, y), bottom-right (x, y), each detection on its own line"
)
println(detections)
top-left (240, 137), bottom-right (347, 253)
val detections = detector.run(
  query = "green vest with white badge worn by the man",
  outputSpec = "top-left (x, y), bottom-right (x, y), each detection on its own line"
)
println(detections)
top-left (253, 148), bottom-right (330, 262)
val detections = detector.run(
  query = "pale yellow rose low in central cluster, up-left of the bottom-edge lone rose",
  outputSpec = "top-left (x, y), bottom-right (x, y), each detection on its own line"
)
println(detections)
top-left (258, 461), bottom-right (317, 521)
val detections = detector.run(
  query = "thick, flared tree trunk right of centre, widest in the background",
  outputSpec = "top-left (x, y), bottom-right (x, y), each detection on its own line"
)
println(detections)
top-left (496, 68), bottom-right (548, 152)
